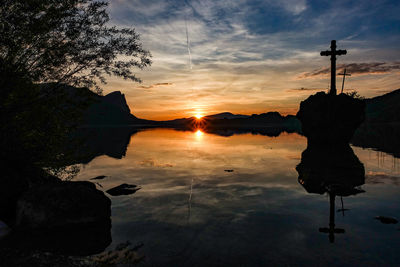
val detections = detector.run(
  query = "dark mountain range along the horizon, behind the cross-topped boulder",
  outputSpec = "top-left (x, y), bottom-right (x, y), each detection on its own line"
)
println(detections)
top-left (36, 83), bottom-right (400, 157)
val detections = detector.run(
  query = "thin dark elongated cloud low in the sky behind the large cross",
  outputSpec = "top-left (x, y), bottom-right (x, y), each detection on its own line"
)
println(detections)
top-left (298, 62), bottom-right (400, 79)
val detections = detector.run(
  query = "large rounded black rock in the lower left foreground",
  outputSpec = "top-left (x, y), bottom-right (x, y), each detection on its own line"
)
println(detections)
top-left (0, 181), bottom-right (111, 256)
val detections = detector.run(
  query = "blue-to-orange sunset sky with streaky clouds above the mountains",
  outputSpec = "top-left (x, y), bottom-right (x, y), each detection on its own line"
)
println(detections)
top-left (103, 0), bottom-right (400, 120)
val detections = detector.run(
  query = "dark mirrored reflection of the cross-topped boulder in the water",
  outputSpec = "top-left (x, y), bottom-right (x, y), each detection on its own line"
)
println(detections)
top-left (296, 145), bottom-right (365, 243)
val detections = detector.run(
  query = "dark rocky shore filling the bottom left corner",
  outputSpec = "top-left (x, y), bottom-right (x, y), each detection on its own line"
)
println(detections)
top-left (0, 165), bottom-right (111, 266)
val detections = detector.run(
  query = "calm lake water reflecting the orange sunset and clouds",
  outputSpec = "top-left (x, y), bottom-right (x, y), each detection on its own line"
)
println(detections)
top-left (75, 129), bottom-right (400, 266)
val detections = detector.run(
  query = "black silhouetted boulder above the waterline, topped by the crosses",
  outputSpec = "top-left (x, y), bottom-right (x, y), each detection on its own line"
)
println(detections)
top-left (296, 92), bottom-right (365, 147)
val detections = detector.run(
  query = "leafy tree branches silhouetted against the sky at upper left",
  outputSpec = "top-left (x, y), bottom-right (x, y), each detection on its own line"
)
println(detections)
top-left (0, 0), bottom-right (151, 94)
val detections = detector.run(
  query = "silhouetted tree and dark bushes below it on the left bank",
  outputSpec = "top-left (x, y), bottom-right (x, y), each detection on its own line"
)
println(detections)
top-left (0, 0), bottom-right (151, 178)
